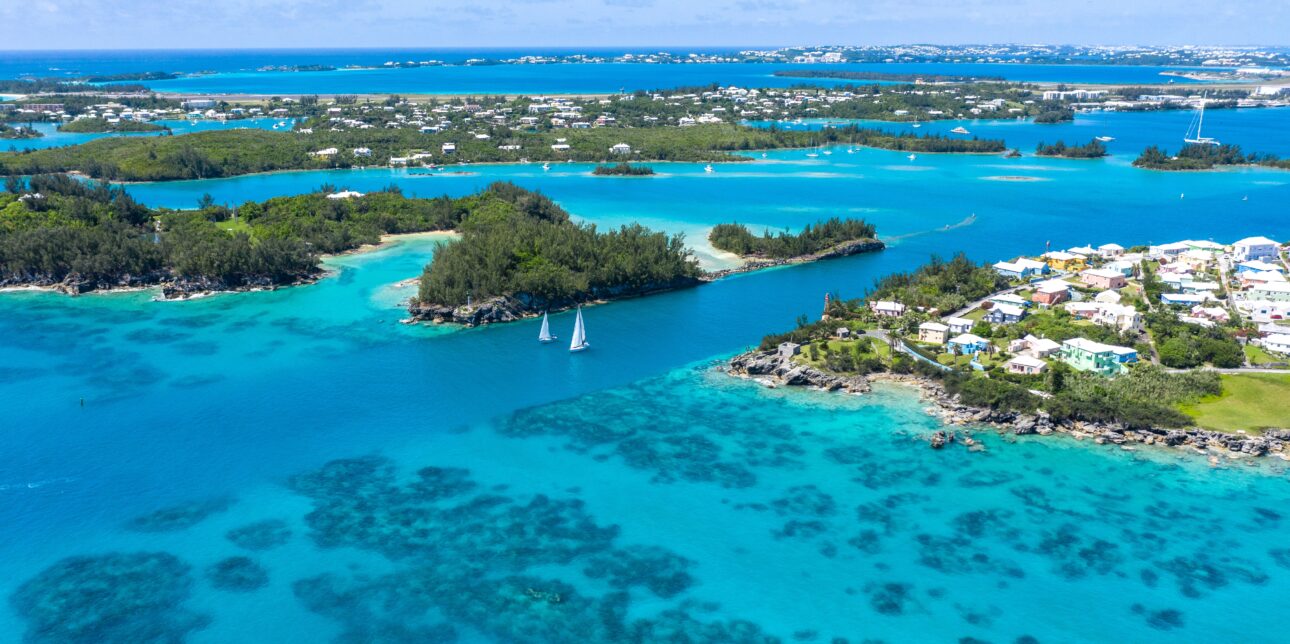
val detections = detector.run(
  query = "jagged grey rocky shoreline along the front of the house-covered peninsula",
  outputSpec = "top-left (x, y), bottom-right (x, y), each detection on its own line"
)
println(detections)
top-left (728, 351), bottom-right (1290, 462)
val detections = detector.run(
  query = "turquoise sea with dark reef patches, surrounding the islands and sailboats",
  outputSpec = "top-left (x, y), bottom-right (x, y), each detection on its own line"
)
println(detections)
top-left (0, 68), bottom-right (1290, 641)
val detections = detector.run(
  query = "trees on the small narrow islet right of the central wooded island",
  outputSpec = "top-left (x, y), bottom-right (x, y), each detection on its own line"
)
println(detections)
top-left (708, 217), bottom-right (875, 259)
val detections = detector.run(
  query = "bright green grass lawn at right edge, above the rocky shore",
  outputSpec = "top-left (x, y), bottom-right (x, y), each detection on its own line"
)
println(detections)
top-left (1182, 373), bottom-right (1290, 434)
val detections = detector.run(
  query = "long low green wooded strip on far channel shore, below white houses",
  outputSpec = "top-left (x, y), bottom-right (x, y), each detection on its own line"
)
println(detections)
top-left (0, 124), bottom-right (1005, 181)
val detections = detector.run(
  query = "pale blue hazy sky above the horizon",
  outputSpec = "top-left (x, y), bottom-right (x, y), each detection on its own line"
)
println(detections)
top-left (0, 0), bottom-right (1290, 50)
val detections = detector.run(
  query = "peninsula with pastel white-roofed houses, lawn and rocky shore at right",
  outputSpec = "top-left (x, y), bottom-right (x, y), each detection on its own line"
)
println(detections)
top-left (730, 237), bottom-right (1290, 462)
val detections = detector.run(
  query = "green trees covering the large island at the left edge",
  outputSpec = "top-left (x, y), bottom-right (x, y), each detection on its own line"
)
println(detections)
top-left (0, 176), bottom-right (516, 297)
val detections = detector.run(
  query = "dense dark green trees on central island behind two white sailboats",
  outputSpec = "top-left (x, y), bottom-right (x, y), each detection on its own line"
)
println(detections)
top-left (418, 183), bottom-right (699, 307)
